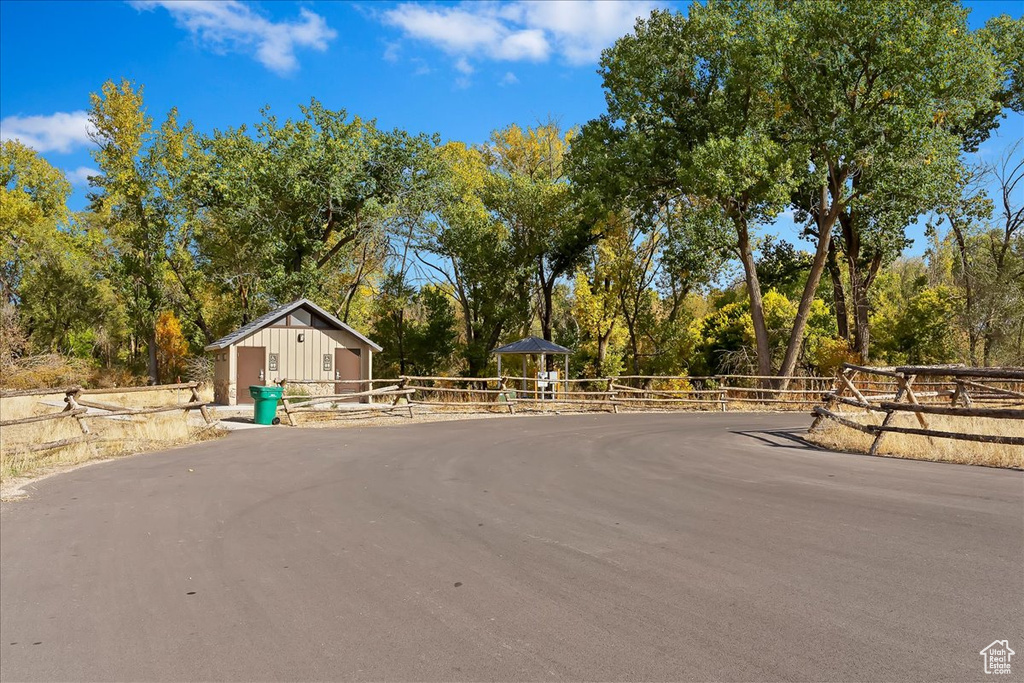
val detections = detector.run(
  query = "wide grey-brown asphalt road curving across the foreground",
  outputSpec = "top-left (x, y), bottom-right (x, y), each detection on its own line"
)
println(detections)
top-left (0, 414), bottom-right (1024, 681)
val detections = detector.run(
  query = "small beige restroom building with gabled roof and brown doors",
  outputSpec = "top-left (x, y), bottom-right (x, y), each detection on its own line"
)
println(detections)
top-left (206, 299), bottom-right (381, 405)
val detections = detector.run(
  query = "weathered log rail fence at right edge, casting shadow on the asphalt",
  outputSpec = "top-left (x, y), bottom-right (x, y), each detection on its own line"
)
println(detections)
top-left (811, 364), bottom-right (1024, 455)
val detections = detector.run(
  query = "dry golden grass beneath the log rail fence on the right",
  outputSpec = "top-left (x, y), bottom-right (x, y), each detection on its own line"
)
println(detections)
top-left (807, 412), bottom-right (1024, 468)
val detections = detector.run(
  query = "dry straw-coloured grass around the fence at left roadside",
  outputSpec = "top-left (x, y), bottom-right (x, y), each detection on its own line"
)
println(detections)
top-left (0, 390), bottom-right (225, 490)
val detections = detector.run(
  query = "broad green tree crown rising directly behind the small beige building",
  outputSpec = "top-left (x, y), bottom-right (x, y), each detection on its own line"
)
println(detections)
top-left (205, 99), bottom-right (431, 318)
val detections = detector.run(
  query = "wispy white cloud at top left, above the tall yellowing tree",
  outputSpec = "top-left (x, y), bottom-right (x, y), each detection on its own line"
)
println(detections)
top-left (130, 0), bottom-right (338, 75)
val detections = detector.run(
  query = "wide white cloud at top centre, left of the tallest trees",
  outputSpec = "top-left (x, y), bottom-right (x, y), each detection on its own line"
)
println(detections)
top-left (383, 0), bottom-right (664, 66)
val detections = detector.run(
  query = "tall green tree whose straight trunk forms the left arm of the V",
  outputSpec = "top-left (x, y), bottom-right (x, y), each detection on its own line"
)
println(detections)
top-left (572, 3), bottom-right (793, 375)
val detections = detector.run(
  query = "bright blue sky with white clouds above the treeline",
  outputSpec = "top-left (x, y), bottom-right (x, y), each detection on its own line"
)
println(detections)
top-left (0, 0), bottom-right (1024, 253)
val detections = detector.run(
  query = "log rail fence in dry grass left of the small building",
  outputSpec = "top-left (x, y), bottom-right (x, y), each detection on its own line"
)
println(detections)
top-left (0, 382), bottom-right (213, 453)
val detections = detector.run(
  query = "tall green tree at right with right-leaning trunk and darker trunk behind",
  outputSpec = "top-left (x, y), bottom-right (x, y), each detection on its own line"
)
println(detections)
top-left (770, 0), bottom-right (998, 368)
